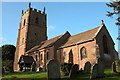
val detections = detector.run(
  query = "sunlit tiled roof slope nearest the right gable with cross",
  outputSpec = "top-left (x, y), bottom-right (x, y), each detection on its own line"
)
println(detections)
top-left (62, 26), bottom-right (100, 47)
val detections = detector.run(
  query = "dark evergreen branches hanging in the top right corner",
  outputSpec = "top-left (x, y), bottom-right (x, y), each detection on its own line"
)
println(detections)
top-left (106, 0), bottom-right (120, 25)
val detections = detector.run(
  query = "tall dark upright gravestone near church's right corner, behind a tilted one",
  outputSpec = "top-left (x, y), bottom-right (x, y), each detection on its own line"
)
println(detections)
top-left (97, 58), bottom-right (105, 78)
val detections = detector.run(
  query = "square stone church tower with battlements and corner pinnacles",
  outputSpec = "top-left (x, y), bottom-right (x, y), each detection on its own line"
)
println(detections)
top-left (14, 3), bottom-right (47, 71)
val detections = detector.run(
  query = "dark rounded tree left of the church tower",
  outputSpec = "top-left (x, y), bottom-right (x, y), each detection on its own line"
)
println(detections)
top-left (1, 45), bottom-right (16, 71)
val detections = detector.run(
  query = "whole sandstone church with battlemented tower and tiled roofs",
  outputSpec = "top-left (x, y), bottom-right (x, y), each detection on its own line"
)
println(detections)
top-left (14, 3), bottom-right (118, 71)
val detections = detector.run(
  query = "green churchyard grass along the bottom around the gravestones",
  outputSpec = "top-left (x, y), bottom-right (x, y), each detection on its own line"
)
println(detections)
top-left (2, 69), bottom-right (120, 80)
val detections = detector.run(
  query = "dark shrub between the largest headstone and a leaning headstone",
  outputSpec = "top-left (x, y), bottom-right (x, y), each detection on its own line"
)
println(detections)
top-left (61, 63), bottom-right (73, 75)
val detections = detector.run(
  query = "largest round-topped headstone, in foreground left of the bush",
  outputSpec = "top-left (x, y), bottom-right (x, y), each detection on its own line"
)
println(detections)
top-left (47, 59), bottom-right (60, 80)
